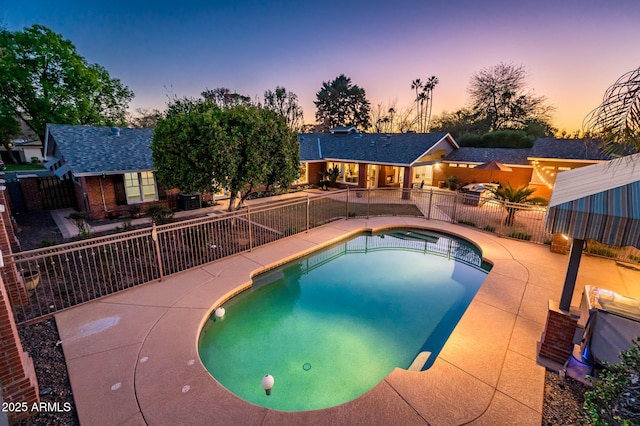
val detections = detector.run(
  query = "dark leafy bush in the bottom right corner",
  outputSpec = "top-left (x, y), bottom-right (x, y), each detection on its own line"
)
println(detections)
top-left (584, 339), bottom-right (640, 426)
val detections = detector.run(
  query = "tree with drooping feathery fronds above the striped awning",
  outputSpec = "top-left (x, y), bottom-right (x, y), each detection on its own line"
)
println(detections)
top-left (583, 68), bottom-right (640, 157)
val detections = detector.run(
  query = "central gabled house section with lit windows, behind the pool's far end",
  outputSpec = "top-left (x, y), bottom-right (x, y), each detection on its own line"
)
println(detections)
top-left (296, 127), bottom-right (459, 188)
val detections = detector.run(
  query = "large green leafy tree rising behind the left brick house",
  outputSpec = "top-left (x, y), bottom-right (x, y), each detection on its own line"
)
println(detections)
top-left (0, 25), bottom-right (133, 140)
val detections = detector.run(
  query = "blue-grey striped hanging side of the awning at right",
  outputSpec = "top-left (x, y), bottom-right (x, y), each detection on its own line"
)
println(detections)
top-left (545, 181), bottom-right (640, 248)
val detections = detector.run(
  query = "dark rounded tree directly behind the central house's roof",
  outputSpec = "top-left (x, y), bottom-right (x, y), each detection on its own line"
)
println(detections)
top-left (314, 74), bottom-right (371, 130)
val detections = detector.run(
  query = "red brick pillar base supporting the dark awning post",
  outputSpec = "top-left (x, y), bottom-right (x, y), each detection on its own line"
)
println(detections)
top-left (539, 300), bottom-right (578, 364)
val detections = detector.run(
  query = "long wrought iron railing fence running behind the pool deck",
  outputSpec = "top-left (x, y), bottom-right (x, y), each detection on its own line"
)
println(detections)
top-left (1, 189), bottom-right (632, 324)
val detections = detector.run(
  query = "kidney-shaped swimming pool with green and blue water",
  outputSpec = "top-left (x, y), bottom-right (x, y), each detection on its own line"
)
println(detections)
top-left (199, 229), bottom-right (489, 411)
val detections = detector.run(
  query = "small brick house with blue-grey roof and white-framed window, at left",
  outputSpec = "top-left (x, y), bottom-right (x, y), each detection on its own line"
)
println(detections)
top-left (44, 124), bottom-right (170, 219)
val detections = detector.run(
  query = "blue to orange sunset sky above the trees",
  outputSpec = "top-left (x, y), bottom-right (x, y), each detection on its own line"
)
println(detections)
top-left (0, 0), bottom-right (640, 132)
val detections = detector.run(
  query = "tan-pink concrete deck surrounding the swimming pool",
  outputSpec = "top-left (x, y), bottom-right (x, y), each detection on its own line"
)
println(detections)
top-left (56, 217), bottom-right (640, 425)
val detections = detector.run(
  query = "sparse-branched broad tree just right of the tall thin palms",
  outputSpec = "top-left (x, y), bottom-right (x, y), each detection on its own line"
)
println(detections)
top-left (468, 62), bottom-right (553, 130)
